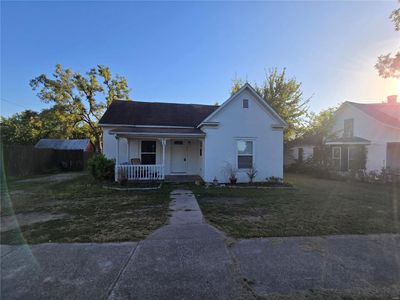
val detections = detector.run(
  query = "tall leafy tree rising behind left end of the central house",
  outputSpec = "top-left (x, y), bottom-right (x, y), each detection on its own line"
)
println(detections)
top-left (30, 64), bottom-right (130, 151)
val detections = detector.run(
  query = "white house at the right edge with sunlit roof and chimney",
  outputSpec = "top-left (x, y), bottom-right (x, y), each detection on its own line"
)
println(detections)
top-left (326, 96), bottom-right (400, 171)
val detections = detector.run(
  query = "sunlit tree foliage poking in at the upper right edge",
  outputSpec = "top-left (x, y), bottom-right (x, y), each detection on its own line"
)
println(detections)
top-left (375, 1), bottom-right (400, 78)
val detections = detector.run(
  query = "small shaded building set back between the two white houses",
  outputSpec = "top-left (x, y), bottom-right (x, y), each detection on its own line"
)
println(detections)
top-left (284, 135), bottom-right (318, 167)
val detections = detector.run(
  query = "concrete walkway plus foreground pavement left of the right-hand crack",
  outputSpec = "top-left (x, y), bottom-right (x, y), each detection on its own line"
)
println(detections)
top-left (1, 190), bottom-right (242, 299)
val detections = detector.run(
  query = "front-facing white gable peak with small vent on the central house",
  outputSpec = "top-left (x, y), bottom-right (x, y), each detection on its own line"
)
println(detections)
top-left (199, 83), bottom-right (287, 128)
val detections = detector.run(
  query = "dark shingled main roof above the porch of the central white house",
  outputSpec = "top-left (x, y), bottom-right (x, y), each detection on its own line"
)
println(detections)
top-left (99, 100), bottom-right (219, 127)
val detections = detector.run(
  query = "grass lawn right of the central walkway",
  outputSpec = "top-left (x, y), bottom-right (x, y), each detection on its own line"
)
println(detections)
top-left (193, 174), bottom-right (400, 238)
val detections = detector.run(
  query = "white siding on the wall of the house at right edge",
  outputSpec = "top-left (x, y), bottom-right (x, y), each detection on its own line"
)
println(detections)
top-left (333, 104), bottom-right (400, 171)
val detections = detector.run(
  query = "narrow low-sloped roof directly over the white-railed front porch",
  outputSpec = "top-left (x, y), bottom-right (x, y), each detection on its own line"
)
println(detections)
top-left (110, 127), bottom-right (205, 137)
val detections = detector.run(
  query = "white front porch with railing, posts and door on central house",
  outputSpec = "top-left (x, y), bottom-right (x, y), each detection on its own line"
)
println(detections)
top-left (110, 128), bottom-right (204, 181)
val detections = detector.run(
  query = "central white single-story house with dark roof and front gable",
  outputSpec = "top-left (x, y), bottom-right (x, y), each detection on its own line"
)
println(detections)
top-left (99, 84), bottom-right (286, 182)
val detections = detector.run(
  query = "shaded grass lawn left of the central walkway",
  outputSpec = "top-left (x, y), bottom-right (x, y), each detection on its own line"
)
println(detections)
top-left (1, 175), bottom-right (171, 244)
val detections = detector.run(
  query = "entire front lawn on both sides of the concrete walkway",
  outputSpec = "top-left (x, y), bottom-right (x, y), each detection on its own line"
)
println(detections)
top-left (1, 174), bottom-right (400, 244)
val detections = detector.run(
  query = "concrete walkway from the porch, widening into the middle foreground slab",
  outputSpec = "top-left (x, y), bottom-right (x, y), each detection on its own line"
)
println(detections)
top-left (110, 190), bottom-right (241, 299)
